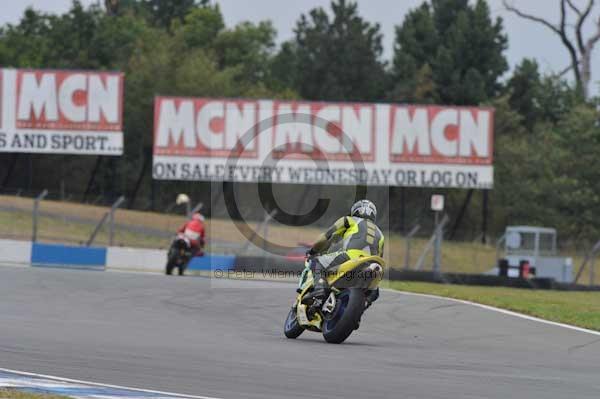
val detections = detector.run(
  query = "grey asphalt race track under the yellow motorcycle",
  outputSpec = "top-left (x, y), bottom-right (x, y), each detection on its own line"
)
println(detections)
top-left (0, 267), bottom-right (600, 399)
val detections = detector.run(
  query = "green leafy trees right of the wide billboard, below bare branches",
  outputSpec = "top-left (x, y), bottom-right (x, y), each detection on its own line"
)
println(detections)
top-left (493, 94), bottom-right (600, 241)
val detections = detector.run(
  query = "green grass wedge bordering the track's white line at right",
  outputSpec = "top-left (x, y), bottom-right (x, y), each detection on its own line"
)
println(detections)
top-left (386, 281), bottom-right (600, 331)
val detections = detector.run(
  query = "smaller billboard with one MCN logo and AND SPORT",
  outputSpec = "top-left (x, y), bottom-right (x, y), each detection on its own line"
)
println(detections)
top-left (0, 69), bottom-right (123, 155)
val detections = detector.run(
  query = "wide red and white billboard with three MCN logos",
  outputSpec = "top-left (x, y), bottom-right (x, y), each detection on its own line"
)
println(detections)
top-left (153, 97), bottom-right (494, 188)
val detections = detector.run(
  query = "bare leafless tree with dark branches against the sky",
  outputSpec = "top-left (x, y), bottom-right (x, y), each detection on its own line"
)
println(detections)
top-left (503, 0), bottom-right (600, 99)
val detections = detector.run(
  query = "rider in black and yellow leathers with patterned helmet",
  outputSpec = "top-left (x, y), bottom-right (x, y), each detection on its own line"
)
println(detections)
top-left (307, 199), bottom-right (385, 305)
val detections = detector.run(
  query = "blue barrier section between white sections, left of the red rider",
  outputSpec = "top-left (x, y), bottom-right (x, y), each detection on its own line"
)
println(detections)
top-left (31, 242), bottom-right (106, 270)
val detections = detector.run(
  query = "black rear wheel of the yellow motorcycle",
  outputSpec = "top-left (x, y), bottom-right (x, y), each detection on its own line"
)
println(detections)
top-left (323, 288), bottom-right (365, 344)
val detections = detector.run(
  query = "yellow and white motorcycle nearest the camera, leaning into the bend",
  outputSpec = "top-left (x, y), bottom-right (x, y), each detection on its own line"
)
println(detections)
top-left (284, 256), bottom-right (385, 344)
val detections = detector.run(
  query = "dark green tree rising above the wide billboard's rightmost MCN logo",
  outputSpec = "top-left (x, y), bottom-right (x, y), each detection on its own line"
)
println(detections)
top-left (389, 0), bottom-right (508, 105)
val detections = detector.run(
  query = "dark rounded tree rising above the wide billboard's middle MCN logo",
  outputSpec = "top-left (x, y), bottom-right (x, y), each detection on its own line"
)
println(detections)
top-left (273, 0), bottom-right (385, 101)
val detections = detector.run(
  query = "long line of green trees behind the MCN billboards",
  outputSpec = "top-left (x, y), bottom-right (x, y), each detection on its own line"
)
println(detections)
top-left (0, 0), bottom-right (600, 241)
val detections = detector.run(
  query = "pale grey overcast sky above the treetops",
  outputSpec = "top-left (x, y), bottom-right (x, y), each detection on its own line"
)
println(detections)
top-left (0, 0), bottom-right (600, 93)
